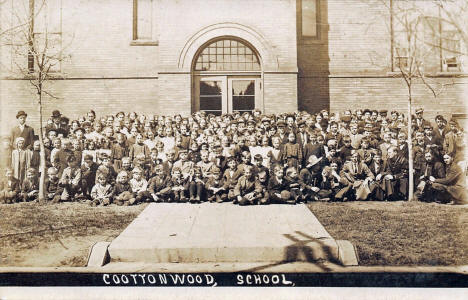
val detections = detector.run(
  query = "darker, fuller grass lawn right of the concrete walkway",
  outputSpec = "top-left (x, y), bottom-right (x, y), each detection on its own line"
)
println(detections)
top-left (309, 201), bottom-right (468, 266)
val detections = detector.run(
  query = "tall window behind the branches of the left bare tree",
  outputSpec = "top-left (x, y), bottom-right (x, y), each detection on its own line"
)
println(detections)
top-left (28, 0), bottom-right (62, 72)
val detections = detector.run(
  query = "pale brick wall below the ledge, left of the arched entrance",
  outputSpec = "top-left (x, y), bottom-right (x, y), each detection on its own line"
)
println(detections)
top-left (0, 79), bottom-right (160, 134)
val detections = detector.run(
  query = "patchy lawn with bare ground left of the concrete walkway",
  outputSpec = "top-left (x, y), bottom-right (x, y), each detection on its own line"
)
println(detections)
top-left (0, 202), bottom-right (146, 267)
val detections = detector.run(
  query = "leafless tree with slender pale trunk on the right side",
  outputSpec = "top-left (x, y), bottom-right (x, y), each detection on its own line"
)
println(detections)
top-left (369, 0), bottom-right (468, 201)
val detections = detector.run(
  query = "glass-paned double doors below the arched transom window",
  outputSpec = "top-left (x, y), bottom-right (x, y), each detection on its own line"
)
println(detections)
top-left (194, 76), bottom-right (261, 115)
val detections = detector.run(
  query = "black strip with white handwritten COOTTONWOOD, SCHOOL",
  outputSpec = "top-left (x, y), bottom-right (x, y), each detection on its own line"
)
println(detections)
top-left (0, 272), bottom-right (468, 288)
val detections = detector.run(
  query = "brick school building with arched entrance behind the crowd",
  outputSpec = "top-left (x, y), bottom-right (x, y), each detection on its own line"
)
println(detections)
top-left (0, 0), bottom-right (468, 132)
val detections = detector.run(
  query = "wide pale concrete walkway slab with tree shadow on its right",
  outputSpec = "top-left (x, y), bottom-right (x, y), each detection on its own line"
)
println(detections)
top-left (108, 203), bottom-right (357, 264)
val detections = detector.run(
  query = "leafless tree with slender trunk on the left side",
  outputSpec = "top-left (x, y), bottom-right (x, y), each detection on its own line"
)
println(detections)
top-left (0, 0), bottom-right (69, 201)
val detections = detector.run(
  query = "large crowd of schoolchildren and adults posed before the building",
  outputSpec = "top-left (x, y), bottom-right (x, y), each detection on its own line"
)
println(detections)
top-left (0, 109), bottom-right (466, 205)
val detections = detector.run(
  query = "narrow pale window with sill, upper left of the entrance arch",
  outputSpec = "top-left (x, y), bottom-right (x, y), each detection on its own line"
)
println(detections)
top-left (133, 0), bottom-right (155, 41)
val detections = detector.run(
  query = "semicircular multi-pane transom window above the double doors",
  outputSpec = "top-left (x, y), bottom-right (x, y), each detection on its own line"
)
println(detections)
top-left (195, 39), bottom-right (260, 71)
